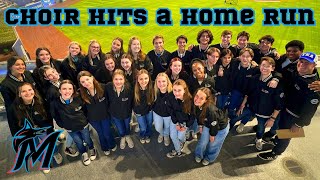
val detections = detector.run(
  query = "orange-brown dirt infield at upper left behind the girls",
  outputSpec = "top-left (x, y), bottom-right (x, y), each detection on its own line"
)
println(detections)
top-left (16, 0), bottom-right (79, 59)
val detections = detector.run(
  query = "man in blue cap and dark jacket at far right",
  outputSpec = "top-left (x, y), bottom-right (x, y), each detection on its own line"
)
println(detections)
top-left (258, 52), bottom-right (320, 161)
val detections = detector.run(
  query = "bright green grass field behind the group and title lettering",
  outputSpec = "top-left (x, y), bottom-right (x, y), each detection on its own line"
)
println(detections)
top-left (61, 0), bottom-right (320, 54)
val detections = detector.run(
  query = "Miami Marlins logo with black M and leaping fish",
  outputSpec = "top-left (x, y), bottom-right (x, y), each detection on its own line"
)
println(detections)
top-left (8, 119), bottom-right (62, 173)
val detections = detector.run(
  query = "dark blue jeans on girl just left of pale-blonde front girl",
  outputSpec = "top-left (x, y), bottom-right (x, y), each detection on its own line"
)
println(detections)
top-left (136, 111), bottom-right (153, 138)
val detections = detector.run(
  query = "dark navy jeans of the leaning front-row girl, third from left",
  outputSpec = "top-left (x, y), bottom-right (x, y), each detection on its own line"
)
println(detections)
top-left (89, 119), bottom-right (116, 151)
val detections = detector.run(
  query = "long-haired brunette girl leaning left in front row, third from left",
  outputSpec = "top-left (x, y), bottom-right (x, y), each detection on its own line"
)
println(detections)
top-left (78, 71), bottom-right (117, 156)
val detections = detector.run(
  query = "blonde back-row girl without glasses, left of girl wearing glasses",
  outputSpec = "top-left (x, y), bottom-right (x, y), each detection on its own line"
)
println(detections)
top-left (60, 41), bottom-right (84, 88)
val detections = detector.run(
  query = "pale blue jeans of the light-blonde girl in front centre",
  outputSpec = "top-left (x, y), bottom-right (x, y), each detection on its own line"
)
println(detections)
top-left (153, 112), bottom-right (171, 137)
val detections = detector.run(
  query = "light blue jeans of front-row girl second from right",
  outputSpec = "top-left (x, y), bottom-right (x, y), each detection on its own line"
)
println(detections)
top-left (170, 121), bottom-right (187, 153)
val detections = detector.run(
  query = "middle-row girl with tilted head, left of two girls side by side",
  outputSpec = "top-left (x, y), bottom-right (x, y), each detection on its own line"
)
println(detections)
top-left (94, 54), bottom-right (116, 84)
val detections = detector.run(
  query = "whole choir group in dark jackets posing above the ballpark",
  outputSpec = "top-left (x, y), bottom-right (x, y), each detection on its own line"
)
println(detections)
top-left (1, 29), bottom-right (320, 173)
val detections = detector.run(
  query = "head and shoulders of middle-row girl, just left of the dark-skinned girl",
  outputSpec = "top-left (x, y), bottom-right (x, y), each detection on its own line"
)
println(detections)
top-left (166, 57), bottom-right (189, 83)
